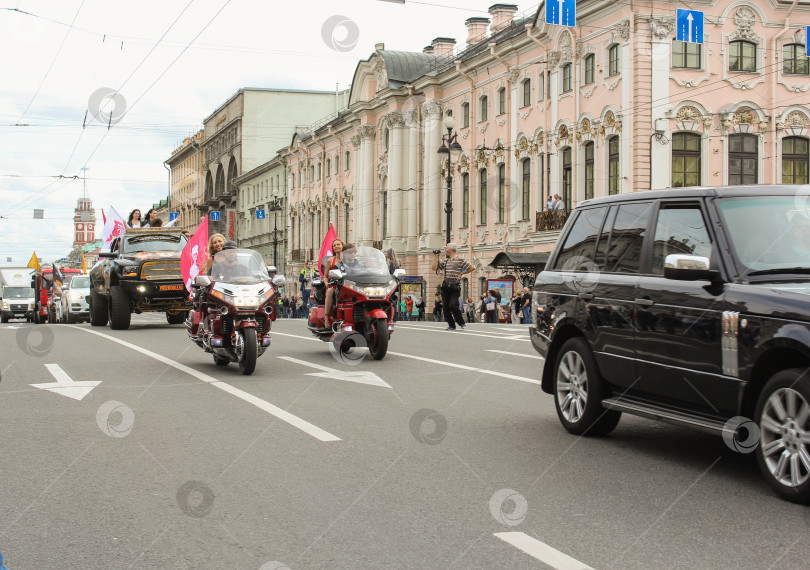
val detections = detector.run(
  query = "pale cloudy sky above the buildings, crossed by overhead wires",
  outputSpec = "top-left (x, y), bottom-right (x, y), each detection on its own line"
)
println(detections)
top-left (0, 0), bottom-right (537, 266)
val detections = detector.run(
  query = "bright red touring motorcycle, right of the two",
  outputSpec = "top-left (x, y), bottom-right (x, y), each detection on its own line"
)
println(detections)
top-left (307, 246), bottom-right (405, 360)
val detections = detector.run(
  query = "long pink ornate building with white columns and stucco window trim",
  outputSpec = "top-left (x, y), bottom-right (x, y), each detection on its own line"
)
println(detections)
top-left (280, 0), bottom-right (810, 298)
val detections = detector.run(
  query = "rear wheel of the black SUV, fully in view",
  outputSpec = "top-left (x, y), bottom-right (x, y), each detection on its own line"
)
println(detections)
top-left (554, 337), bottom-right (621, 435)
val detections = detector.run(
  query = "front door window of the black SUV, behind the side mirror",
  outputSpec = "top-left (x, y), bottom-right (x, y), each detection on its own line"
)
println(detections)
top-left (650, 204), bottom-right (712, 275)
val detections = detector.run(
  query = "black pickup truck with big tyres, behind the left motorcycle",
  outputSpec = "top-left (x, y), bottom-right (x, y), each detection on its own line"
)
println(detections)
top-left (88, 228), bottom-right (191, 330)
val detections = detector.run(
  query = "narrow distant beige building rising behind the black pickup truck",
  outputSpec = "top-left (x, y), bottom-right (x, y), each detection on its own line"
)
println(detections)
top-left (164, 130), bottom-right (204, 232)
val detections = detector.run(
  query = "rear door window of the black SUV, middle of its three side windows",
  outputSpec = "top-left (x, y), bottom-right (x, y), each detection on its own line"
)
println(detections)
top-left (597, 202), bottom-right (652, 273)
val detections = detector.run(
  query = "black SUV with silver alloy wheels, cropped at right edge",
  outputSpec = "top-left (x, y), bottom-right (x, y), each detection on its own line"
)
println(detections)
top-left (530, 186), bottom-right (810, 503)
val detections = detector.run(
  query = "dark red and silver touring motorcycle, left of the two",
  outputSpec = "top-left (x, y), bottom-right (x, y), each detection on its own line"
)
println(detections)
top-left (186, 249), bottom-right (284, 375)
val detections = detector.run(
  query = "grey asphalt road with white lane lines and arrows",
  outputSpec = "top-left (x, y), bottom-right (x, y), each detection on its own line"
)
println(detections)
top-left (0, 315), bottom-right (810, 570)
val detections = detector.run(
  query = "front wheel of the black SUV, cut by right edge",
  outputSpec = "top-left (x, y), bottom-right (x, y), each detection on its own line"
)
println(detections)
top-left (755, 368), bottom-right (810, 504)
